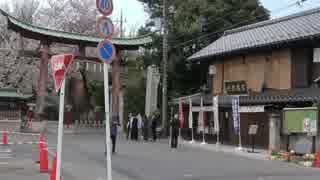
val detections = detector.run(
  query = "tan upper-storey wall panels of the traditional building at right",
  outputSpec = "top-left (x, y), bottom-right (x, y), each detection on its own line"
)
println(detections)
top-left (213, 49), bottom-right (292, 94)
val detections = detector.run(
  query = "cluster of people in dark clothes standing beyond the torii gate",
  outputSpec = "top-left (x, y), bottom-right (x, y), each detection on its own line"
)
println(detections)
top-left (127, 113), bottom-right (158, 141)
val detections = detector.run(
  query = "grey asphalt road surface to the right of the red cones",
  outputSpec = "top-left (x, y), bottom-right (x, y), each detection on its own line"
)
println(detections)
top-left (45, 134), bottom-right (320, 180)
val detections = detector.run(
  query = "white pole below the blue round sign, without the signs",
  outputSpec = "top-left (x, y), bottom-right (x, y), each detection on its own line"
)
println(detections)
top-left (103, 63), bottom-right (112, 180)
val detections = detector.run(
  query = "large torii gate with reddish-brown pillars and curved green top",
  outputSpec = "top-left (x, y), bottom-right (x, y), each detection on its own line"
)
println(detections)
top-left (0, 9), bottom-right (152, 126)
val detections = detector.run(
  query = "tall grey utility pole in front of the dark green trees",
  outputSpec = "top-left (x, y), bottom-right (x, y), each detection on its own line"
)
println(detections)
top-left (162, 0), bottom-right (168, 134)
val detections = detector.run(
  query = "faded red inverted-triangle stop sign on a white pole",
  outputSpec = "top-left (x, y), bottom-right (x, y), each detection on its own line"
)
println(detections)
top-left (50, 54), bottom-right (74, 92)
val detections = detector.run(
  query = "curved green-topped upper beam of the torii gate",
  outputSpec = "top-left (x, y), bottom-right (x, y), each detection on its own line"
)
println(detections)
top-left (0, 9), bottom-right (152, 46)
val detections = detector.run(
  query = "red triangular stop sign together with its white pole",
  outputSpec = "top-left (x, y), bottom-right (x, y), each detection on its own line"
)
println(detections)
top-left (50, 54), bottom-right (74, 180)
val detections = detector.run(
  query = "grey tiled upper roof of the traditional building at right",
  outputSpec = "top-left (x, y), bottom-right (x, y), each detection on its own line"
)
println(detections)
top-left (188, 8), bottom-right (320, 60)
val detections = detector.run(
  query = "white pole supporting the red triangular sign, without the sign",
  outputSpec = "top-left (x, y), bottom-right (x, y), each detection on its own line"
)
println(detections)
top-left (56, 79), bottom-right (66, 180)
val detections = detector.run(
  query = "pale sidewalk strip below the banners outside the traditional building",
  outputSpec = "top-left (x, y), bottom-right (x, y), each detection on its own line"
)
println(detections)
top-left (182, 140), bottom-right (268, 160)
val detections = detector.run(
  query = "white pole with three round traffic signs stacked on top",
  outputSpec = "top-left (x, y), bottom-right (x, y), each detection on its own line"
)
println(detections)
top-left (96, 0), bottom-right (116, 180)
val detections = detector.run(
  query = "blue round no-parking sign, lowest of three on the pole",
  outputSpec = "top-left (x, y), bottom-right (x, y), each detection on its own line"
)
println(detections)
top-left (98, 39), bottom-right (116, 63)
